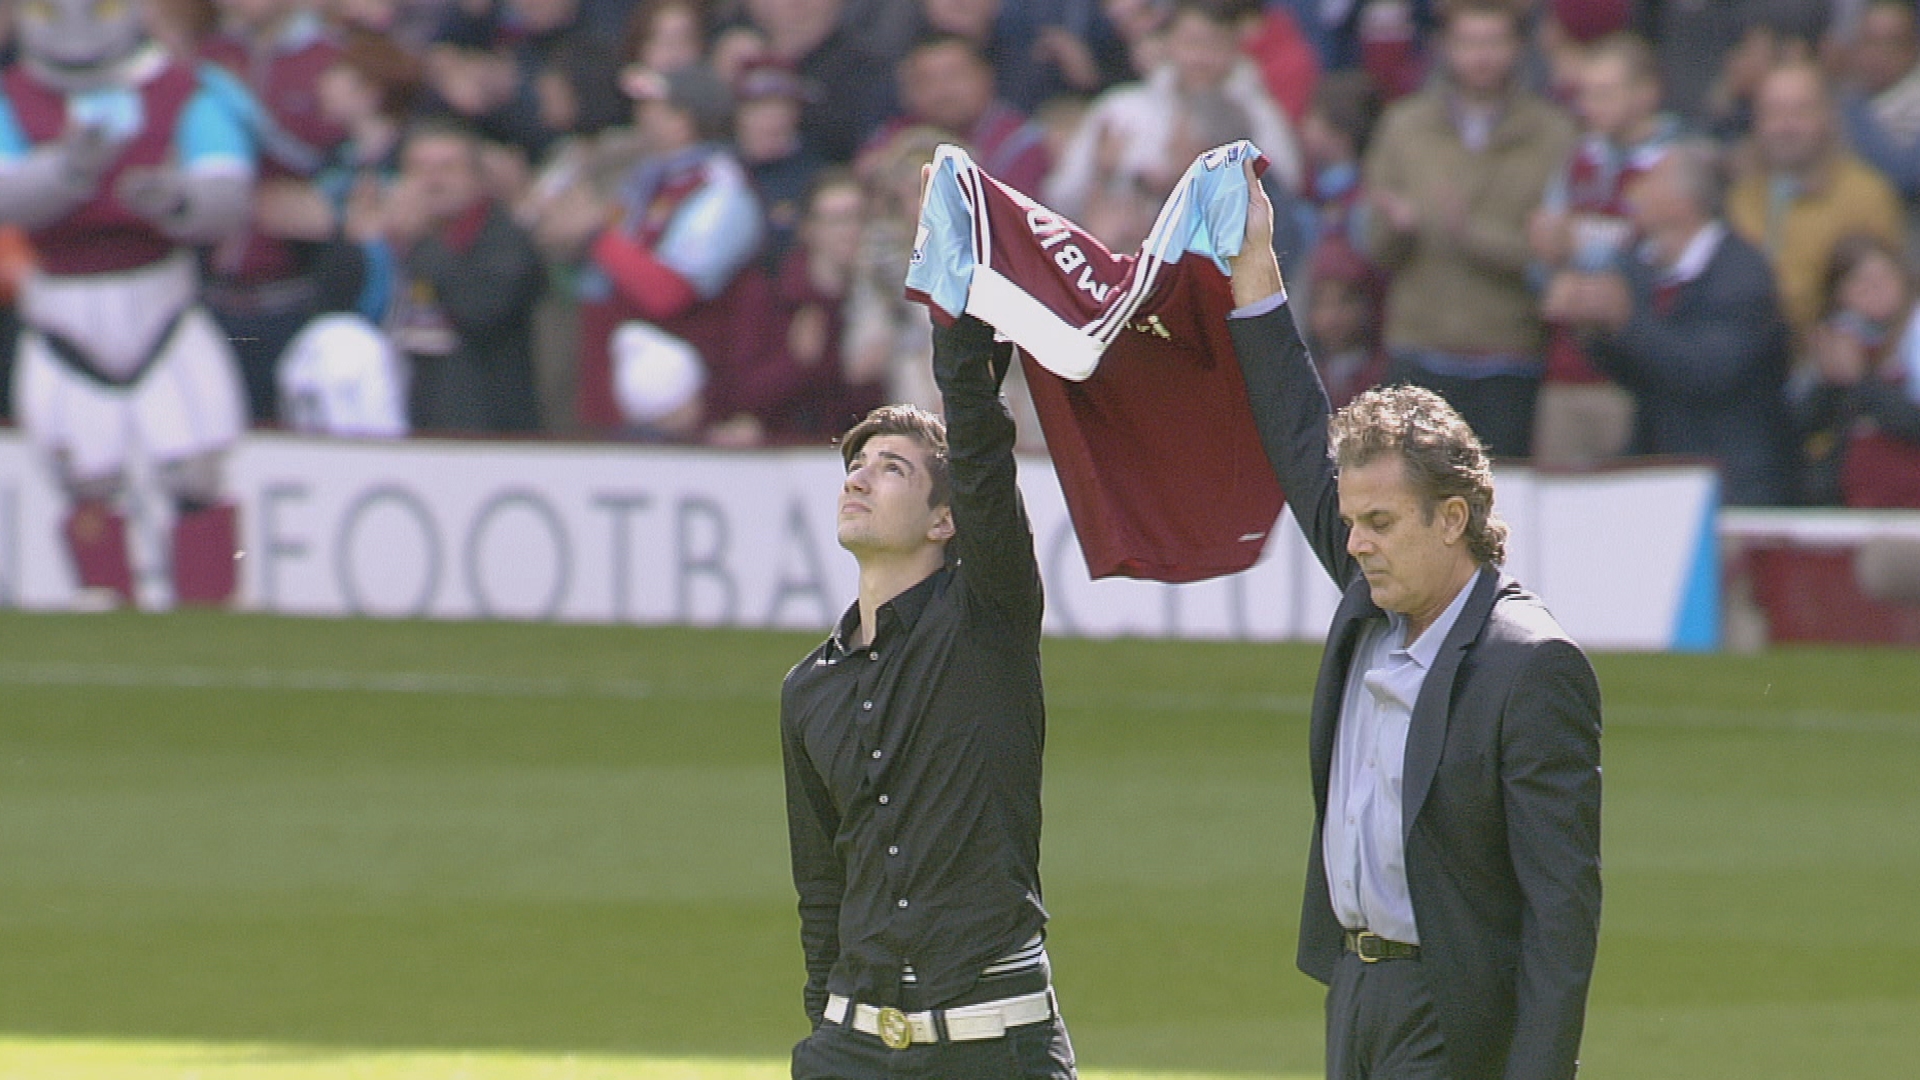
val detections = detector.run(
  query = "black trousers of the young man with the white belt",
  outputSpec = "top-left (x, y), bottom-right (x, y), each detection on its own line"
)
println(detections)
top-left (793, 1017), bottom-right (1075, 1080)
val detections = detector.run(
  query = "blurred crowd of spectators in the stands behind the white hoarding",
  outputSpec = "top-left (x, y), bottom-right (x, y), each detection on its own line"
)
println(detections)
top-left (0, 0), bottom-right (1920, 505)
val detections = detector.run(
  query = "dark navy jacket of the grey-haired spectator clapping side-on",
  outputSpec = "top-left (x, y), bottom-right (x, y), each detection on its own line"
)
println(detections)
top-left (1590, 231), bottom-right (1793, 505)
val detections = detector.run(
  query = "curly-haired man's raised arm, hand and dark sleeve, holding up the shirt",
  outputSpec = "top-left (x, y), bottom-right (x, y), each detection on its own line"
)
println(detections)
top-left (1229, 168), bottom-right (1357, 586)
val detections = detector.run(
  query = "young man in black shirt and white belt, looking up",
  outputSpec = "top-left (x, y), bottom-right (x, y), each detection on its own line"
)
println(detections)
top-left (780, 317), bottom-right (1075, 1080)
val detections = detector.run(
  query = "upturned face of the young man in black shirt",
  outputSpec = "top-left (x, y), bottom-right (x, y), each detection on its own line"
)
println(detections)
top-left (835, 434), bottom-right (952, 557)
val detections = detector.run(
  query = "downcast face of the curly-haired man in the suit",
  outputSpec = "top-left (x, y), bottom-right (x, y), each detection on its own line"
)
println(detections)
top-left (1338, 455), bottom-right (1459, 615)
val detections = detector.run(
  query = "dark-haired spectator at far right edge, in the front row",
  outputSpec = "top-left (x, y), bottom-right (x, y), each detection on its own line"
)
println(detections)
top-left (1795, 236), bottom-right (1920, 507)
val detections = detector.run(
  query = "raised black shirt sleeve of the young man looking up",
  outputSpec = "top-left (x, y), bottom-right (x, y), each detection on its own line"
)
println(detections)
top-left (933, 315), bottom-right (1043, 634)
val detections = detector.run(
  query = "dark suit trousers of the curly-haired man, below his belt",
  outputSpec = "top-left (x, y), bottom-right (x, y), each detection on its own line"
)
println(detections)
top-left (1327, 953), bottom-right (1448, 1080)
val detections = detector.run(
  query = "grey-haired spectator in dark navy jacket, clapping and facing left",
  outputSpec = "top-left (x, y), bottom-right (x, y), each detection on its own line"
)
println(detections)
top-left (1546, 140), bottom-right (1793, 505)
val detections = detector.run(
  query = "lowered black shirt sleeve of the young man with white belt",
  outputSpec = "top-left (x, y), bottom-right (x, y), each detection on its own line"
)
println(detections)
top-left (780, 684), bottom-right (847, 1028)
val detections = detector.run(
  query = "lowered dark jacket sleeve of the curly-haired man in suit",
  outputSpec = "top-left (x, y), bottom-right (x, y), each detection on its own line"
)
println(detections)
top-left (1500, 642), bottom-right (1599, 1080)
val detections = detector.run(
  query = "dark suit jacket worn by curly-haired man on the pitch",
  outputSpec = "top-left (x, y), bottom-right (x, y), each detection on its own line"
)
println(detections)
top-left (1233, 306), bottom-right (1599, 1080)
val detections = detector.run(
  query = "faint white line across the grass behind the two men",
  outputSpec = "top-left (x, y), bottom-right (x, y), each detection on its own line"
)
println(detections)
top-left (0, 663), bottom-right (1920, 736)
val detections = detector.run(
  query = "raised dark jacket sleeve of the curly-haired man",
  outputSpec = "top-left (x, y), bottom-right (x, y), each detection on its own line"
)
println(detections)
top-left (1227, 304), bottom-right (1357, 588)
